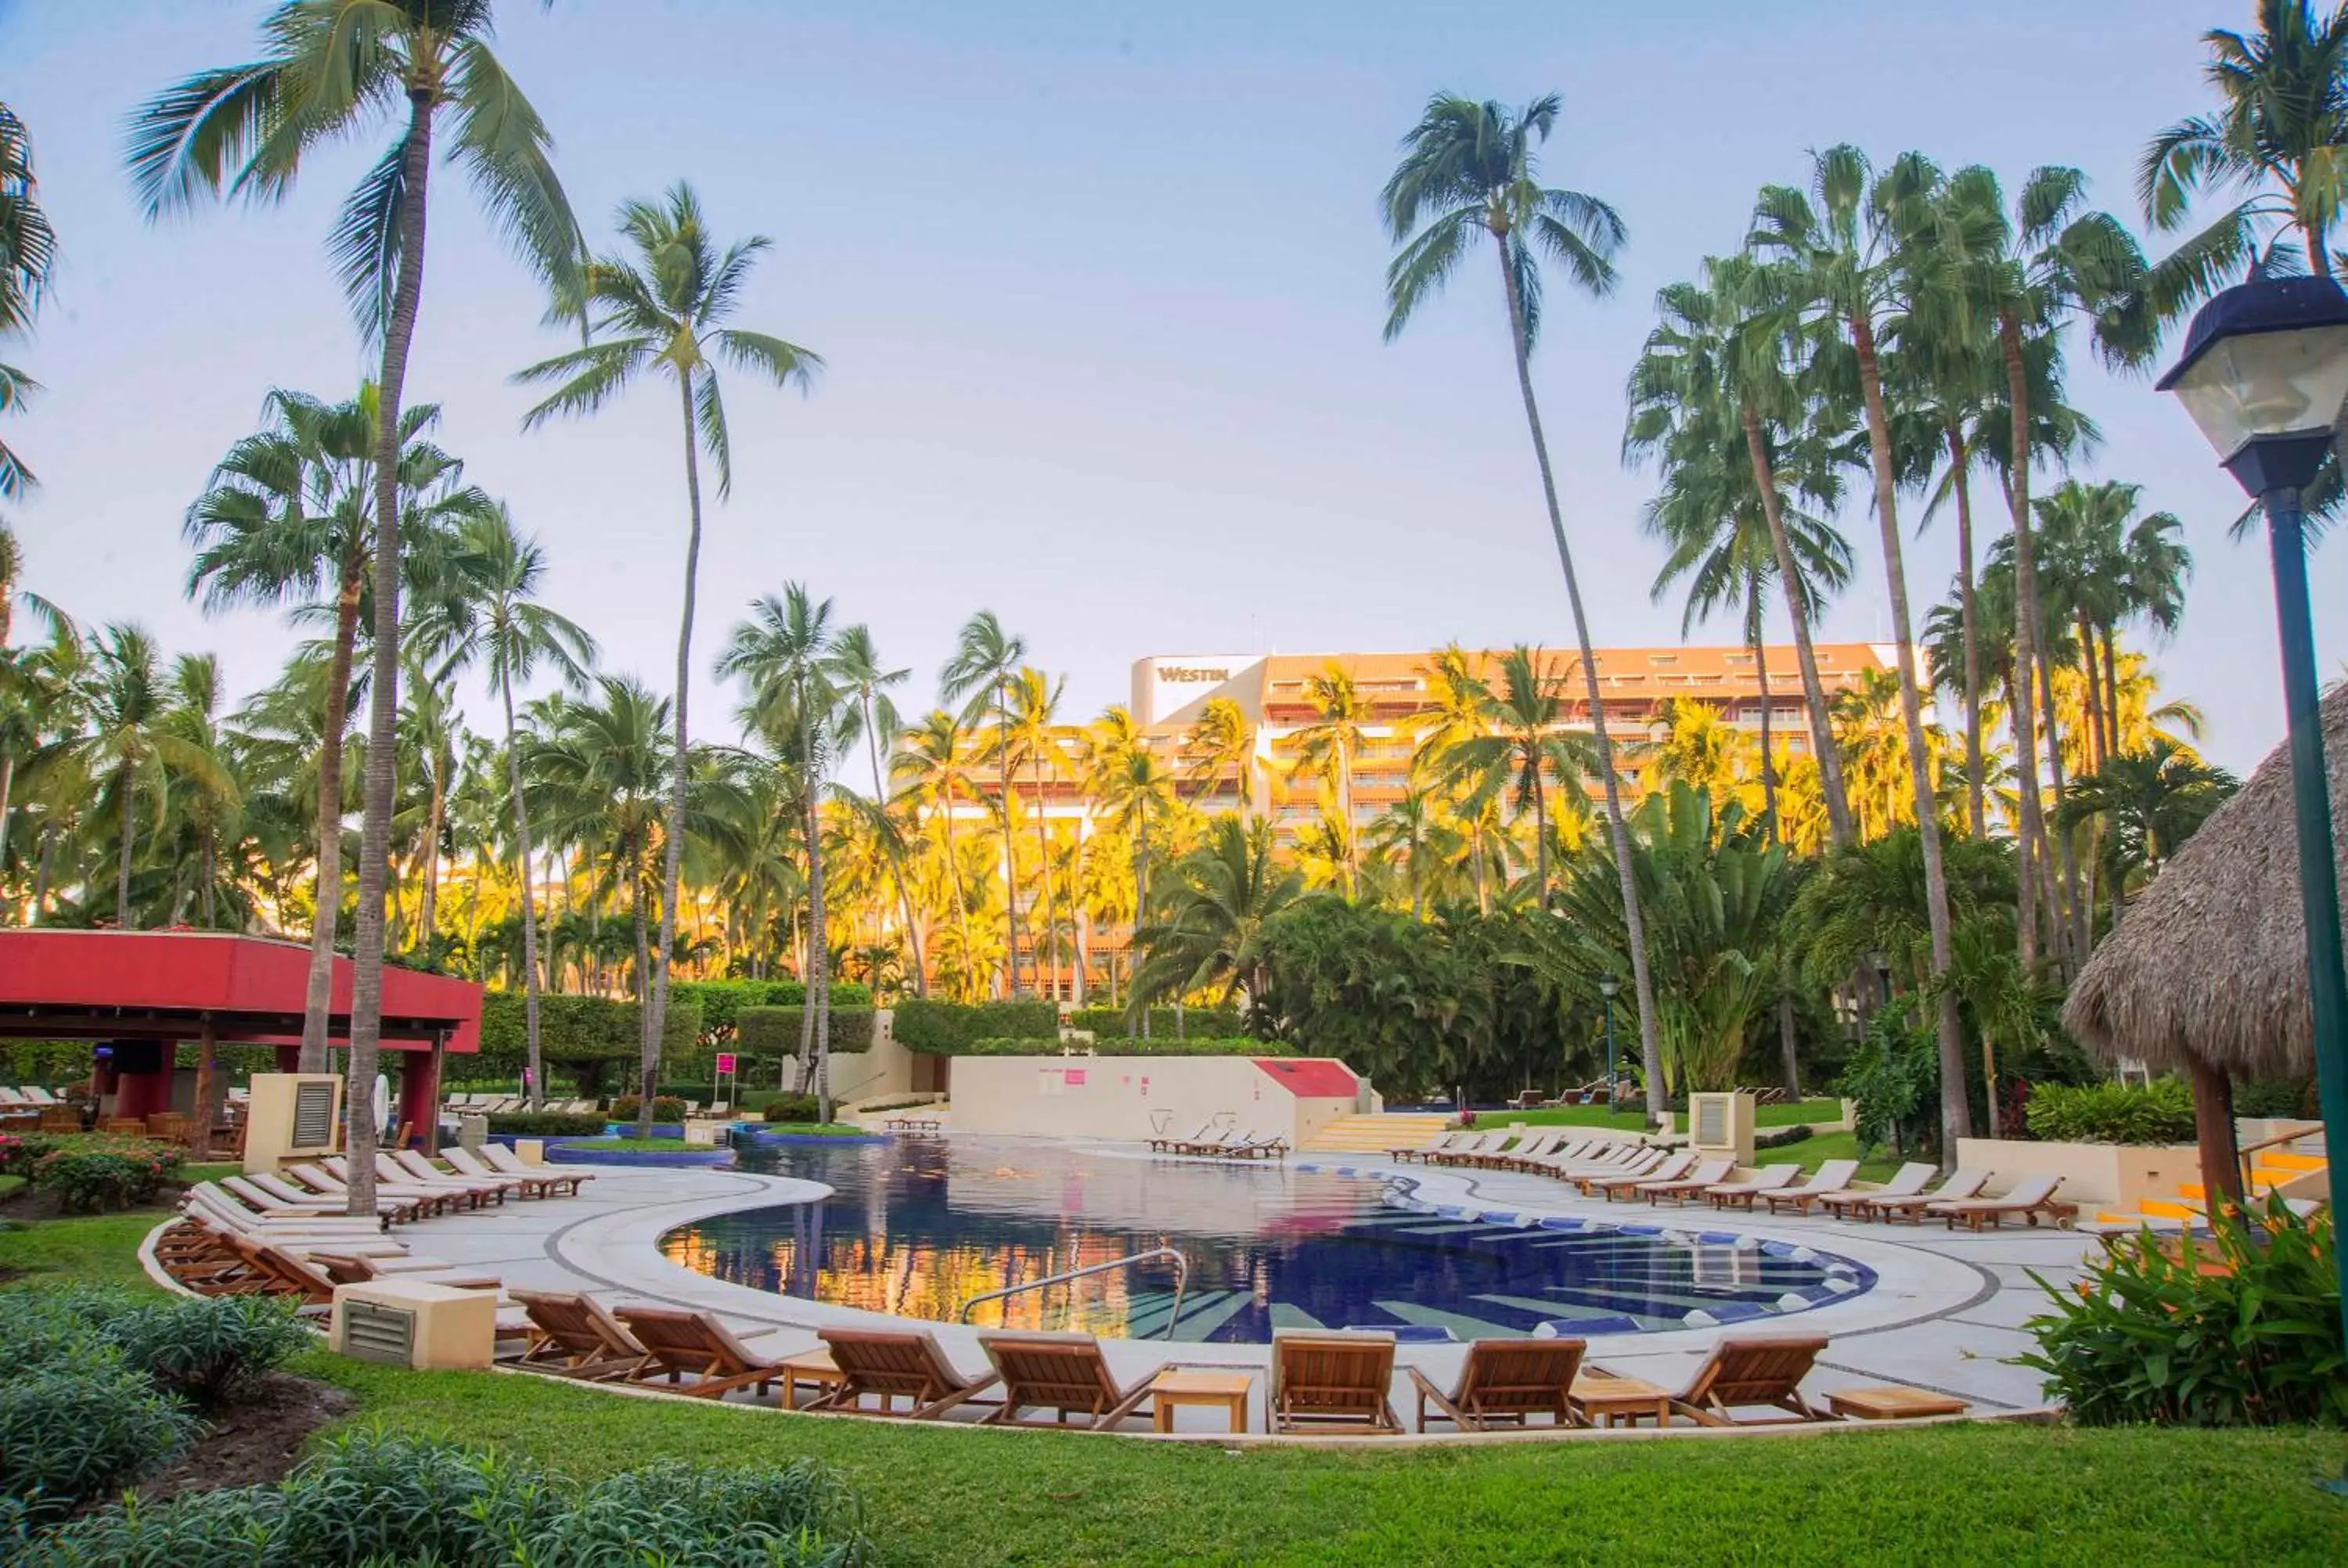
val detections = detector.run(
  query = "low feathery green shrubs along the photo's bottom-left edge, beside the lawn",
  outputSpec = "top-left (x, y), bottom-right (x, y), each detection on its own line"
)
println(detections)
top-left (19, 1430), bottom-right (871, 1568)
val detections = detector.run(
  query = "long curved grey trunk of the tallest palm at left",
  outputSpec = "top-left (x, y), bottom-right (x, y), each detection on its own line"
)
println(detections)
top-left (343, 85), bottom-right (439, 1216)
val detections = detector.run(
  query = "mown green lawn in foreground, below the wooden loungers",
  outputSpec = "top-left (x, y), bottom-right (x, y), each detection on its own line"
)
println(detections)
top-left (0, 1214), bottom-right (2348, 1568)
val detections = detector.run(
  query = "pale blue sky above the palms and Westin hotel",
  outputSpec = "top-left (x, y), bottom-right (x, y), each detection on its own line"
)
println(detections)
top-left (0, 0), bottom-right (2348, 768)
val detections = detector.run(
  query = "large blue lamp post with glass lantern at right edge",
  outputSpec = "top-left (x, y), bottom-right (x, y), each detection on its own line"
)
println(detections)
top-left (2155, 272), bottom-right (2348, 1361)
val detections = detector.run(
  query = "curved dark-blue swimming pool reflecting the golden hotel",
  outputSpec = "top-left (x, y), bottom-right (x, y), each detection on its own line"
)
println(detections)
top-left (660, 1136), bottom-right (1874, 1343)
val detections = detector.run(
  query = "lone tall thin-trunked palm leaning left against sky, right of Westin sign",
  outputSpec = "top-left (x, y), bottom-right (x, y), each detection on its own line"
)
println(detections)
top-left (1383, 94), bottom-right (1665, 1110)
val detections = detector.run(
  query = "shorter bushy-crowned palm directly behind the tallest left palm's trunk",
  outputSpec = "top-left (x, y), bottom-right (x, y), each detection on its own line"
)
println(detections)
top-left (181, 385), bottom-right (491, 1073)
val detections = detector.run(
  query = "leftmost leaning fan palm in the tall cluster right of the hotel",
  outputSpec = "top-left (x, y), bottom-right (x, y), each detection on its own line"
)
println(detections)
top-left (1622, 256), bottom-right (1853, 845)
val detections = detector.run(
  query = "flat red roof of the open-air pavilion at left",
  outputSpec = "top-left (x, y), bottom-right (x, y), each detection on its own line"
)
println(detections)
top-left (0, 930), bottom-right (481, 1052)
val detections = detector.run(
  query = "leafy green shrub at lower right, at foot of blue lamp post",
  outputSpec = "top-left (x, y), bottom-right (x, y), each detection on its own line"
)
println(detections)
top-left (2015, 1197), bottom-right (2348, 1427)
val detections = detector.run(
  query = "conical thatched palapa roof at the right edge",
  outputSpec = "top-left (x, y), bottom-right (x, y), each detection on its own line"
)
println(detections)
top-left (2062, 685), bottom-right (2348, 1077)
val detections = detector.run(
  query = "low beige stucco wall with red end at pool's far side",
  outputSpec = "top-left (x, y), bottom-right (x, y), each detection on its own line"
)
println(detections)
top-left (953, 1054), bottom-right (1355, 1143)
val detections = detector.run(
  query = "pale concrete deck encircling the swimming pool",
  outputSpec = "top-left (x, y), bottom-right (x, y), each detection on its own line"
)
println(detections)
top-left (380, 1143), bottom-right (2097, 1432)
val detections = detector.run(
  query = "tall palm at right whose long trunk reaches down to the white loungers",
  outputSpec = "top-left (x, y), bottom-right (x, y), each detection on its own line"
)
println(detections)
top-left (1752, 143), bottom-right (1982, 1157)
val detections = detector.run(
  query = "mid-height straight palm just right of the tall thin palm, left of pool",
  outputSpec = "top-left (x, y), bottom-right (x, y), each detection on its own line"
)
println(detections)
top-left (723, 582), bottom-right (845, 1113)
